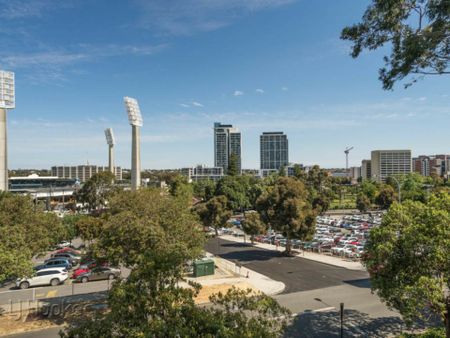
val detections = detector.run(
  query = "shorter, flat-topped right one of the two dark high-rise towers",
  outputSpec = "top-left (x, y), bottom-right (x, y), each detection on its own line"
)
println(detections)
top-left (259, 132), bottom-right (289, 177)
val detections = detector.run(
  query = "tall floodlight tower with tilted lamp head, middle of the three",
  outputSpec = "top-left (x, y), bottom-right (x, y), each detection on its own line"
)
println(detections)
top-left (123, 96), bottom-right (142, 191)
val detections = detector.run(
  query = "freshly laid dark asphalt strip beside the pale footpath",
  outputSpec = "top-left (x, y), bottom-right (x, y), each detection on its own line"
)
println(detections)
top-left (205, 238), bottom-right (369, 293)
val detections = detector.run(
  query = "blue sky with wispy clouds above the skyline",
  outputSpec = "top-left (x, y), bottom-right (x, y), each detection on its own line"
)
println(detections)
top-left (0, 0), bottom-right (450, 168)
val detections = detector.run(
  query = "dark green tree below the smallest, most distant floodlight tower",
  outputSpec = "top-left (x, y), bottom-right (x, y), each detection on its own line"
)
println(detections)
top-left (77, 171), bottom-right (115, 210)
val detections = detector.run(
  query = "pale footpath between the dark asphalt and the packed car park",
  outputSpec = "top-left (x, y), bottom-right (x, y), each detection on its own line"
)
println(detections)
top-left (220, 235), bottom-right (366, 271)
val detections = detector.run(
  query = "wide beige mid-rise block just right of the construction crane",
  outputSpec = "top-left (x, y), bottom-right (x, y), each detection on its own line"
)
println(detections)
top-left (371, 150), bottom-right (412, 182)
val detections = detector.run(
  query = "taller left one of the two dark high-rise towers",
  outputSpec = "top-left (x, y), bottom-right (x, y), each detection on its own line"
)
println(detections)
top-left (214, 122), bottom-right (242, 173)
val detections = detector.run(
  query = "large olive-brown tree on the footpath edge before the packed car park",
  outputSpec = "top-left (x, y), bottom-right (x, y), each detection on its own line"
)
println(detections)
top-left (257, 177), bottom-right (317, 254)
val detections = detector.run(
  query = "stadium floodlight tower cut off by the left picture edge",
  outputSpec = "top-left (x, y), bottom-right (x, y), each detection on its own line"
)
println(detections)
top-left (0, 70), bottom-right (16, 191)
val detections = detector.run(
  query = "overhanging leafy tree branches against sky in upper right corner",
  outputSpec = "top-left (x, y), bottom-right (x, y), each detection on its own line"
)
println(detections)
top-left (341, 0), bottom-right (450, 89)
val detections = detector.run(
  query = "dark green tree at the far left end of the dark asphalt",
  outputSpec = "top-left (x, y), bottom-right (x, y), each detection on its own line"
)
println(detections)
top-left (196, 195), bottom-right (232, 236)
